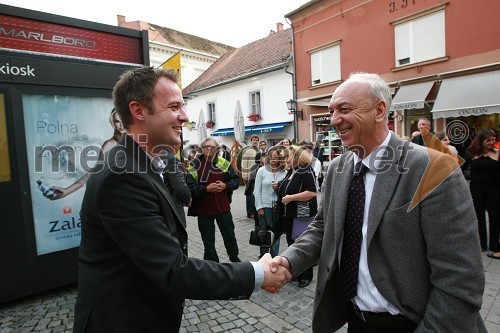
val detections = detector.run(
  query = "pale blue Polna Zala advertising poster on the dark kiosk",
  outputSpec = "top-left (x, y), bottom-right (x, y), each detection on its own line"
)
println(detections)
top-left (23, 95), bottom-right (115, 255)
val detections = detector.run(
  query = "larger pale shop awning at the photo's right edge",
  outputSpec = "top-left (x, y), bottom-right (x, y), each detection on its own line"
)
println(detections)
top-left (432, 71), bottom-right (500, 119)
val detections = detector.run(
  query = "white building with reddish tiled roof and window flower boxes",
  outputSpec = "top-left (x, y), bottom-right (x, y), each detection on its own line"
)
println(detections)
top-left (183, 24), bottom-right (294, 147)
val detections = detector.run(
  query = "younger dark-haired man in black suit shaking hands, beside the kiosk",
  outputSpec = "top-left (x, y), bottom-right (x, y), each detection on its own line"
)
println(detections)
top-left (74, 67), bottom-right (290, 333)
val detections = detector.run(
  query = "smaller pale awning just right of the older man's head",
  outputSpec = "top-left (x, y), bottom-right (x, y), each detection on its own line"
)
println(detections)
top-left (390, 81), bottom-right (434, 111)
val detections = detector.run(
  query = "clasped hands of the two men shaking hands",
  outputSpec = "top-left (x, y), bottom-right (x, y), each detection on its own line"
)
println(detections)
top-left (259, 253), bottom-right (292, 293)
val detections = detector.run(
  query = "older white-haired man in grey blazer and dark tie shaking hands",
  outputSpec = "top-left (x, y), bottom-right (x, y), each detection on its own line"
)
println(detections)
top-left (273, 73), bottom-right (486, 333)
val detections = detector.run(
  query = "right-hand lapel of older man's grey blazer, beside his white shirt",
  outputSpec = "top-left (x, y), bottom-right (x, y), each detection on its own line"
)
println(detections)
top-left (366, 134), bottom-right (409, 246)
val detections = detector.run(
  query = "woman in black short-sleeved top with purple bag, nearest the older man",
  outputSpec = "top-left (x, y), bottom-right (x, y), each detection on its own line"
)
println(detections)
top-left (278, 146), bottom-right (318, 288)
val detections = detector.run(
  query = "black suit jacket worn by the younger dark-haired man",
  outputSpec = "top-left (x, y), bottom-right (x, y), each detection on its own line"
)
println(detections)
top-left (74, 135), bottom-right (255, 333)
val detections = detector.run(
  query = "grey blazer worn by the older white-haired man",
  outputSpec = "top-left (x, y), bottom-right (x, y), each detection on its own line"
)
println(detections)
top-left (282, 134), bottom-right (486, 333)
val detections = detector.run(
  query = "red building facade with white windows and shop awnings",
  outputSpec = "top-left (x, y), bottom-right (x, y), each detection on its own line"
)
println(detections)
top-left (286, 0), bottom-right (500, 159)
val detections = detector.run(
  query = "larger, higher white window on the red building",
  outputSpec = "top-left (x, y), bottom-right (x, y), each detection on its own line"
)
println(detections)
top-left (394, 11), bottom-right (445, 67)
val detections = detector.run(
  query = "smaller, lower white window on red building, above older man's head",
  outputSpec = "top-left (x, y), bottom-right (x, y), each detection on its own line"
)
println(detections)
top-left (311, 44), bottom-right (340, 86)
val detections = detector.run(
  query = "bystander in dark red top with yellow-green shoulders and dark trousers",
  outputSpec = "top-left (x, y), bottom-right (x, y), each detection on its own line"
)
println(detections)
top-left (187, 137), bottom-right (241, 262)
